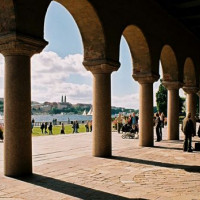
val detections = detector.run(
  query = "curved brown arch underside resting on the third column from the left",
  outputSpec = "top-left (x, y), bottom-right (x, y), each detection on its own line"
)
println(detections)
top-left (123, 25), bottom-right (151, 74)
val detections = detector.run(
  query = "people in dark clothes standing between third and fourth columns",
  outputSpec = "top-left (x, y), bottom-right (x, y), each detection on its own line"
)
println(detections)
top-left (153, 112), bottom-right (165, 142)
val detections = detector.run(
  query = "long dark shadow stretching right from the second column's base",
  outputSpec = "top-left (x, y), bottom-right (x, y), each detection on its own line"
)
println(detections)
top-left (111, 156), bottom-right (200, 173)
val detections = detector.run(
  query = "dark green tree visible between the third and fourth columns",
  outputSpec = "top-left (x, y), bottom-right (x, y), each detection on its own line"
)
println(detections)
top-left (156, 79), bottom-right (167, 116)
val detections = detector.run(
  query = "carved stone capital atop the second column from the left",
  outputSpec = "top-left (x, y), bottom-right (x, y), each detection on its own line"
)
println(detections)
top-left (83, 59), bottom-right (120, 74)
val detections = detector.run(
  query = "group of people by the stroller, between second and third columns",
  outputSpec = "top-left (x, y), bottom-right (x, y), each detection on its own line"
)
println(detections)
top-left (114, 112), bottom-right (139, 133)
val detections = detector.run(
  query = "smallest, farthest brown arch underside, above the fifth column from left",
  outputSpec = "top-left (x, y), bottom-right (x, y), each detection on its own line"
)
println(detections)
top-left (183, 57), bottom-right (197, 87)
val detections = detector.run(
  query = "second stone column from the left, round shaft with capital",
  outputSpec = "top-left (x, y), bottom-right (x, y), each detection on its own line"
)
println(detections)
top-left (83, 62), bottom-right (118, 157)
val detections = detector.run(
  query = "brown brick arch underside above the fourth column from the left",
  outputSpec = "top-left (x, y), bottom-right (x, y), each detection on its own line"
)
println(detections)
top-left (160, 45), bottom-right (179, 81)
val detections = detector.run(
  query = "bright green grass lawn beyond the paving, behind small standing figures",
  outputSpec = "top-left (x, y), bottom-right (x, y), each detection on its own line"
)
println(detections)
top-left (32, 124), bottom-right (85, 136)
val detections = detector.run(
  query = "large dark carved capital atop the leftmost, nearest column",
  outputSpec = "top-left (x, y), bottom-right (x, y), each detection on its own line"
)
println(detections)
top-left (0, 34), bottom-right (48, 56)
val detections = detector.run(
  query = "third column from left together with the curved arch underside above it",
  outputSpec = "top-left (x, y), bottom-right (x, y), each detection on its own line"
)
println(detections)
top-left (120, 25), bottom-right (158, 146)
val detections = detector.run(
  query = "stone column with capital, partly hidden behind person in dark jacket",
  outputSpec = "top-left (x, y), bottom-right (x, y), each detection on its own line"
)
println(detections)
top-left (183, 86), bottom-right (199, 130)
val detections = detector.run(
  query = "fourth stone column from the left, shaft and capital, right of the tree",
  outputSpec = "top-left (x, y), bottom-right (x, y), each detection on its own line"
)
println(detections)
top-left (163, 81), bottom-right (182, 140)
